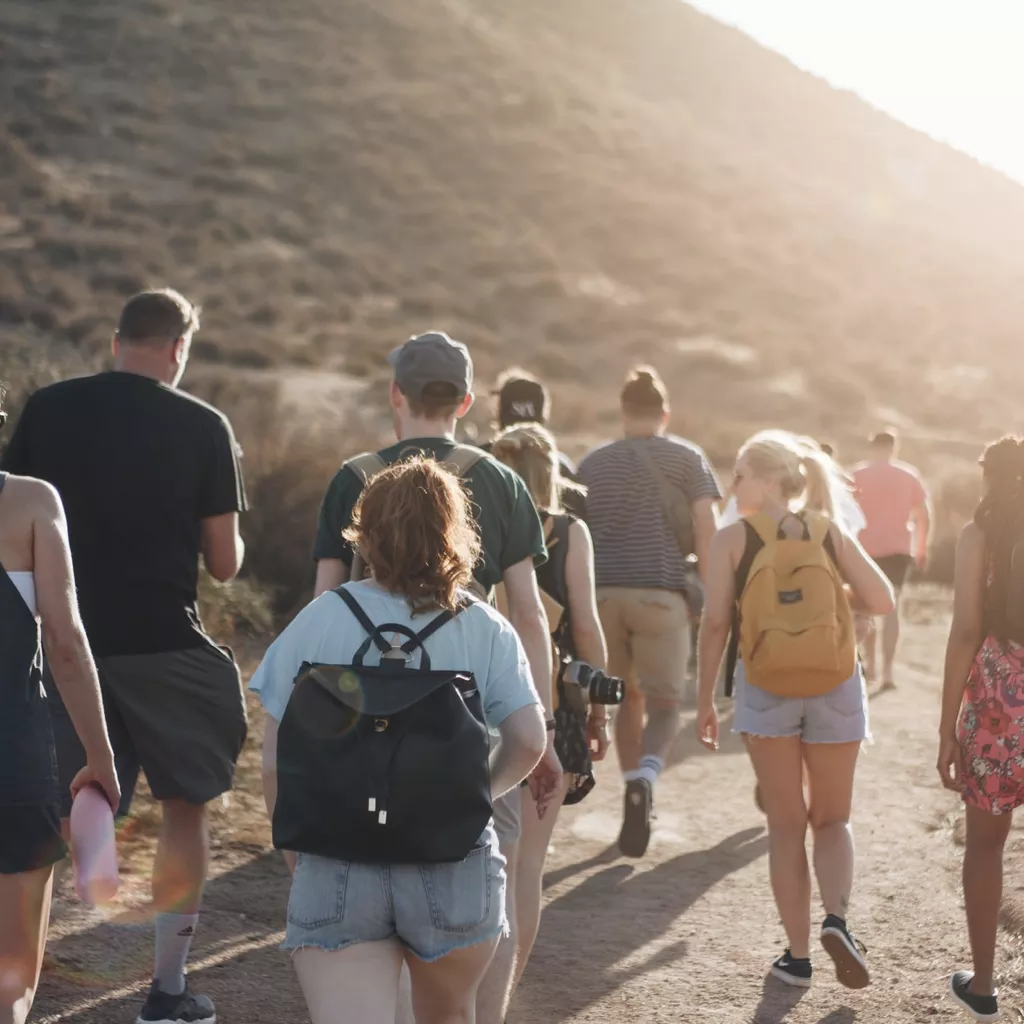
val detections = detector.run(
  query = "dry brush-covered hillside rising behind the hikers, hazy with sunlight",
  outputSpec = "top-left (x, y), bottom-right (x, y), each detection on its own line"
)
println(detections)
top-left (0, 0), bottom-right (1024, 456)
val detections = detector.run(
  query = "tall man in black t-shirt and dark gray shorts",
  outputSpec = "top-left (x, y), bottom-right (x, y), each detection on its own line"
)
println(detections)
top-left (2, 291), bottom-right (247, 1024)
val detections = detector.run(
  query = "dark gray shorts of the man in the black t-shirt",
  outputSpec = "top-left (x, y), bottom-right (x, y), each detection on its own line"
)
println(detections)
top-left (47, 643), bottom-right (248, 815)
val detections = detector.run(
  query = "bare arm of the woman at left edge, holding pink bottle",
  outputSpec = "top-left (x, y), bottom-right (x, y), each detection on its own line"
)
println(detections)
top-left (33, 481), bottom-right (121, 811)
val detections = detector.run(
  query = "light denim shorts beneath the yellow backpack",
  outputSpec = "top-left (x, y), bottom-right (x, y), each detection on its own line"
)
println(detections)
top-left (732, 662), bottom-right (870, 743)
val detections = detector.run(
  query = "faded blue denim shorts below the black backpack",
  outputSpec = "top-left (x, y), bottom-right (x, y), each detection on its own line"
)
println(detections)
top-left (282, 827), bottom-right (508, 963)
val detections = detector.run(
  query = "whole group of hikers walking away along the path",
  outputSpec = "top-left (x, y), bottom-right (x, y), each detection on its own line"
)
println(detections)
top-left (0, 290), bottom-right (1024, 1024)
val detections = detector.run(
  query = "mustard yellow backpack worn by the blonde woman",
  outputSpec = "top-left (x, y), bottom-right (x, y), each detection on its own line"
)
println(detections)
top-left (739, 513), bottom-right (856, 697)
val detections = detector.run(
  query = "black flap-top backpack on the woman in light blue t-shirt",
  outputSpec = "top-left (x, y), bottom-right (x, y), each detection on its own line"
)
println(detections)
top-left (273, 587), bottom-right (492, 864)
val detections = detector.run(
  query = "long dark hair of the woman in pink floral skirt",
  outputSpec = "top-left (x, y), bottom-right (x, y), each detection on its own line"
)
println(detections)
top-left (974, 437), bottom-right (1024, 641)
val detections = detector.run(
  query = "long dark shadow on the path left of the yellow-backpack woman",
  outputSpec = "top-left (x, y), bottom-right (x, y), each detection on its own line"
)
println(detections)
top-left (510, 828), bottom-right (765, 1024)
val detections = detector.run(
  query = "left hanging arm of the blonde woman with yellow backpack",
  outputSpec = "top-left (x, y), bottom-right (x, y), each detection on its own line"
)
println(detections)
top-left (696, 523), bottom-right (745, 751)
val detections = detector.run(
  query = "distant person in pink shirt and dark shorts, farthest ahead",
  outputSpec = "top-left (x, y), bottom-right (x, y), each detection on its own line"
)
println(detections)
top-left (851, 430), bottom-right (931, 689)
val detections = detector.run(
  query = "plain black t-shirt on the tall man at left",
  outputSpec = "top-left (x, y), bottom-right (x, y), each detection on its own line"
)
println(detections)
top-left (2, 373), bottom-right (246, 656)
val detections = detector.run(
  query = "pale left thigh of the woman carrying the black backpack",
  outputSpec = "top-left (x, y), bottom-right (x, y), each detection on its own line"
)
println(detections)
top-left (292, 938), bottom-right (405, 1024)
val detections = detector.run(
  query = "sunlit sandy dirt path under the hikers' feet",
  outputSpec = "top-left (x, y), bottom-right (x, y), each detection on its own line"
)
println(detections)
top-left (37, 597), bottom-right (1007, 1024)
